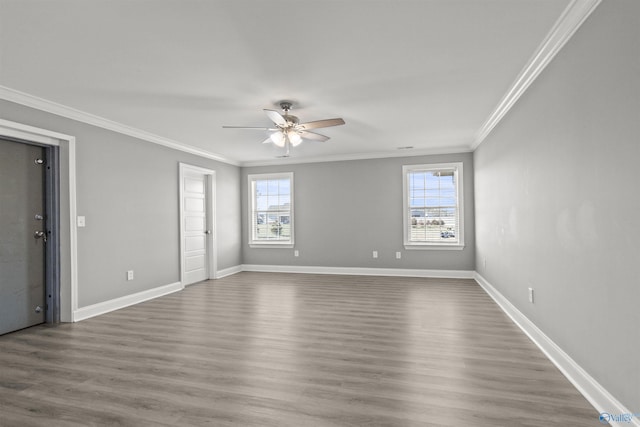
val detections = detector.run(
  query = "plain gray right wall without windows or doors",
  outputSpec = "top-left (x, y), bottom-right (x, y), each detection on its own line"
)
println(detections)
top-left (474, 0), bottom-right (640, 412)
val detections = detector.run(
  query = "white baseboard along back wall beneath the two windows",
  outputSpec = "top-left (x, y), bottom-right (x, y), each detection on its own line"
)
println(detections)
top-left (241, 264), bottom-right (475, 279)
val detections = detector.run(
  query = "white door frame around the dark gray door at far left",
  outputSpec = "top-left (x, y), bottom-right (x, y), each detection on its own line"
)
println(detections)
top-left (0, 119), bottom-right (78, 323)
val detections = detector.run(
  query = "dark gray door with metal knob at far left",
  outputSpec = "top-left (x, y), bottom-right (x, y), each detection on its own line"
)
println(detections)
top-left (0, 140), bottom-right (47, 334)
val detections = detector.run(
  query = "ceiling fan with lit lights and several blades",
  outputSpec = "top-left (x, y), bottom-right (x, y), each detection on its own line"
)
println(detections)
top-left (222, 101), bottom-right (344, 157)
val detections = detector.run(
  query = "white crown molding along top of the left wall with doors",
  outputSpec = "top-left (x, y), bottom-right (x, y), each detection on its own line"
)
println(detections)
top-left (0, 86), bottom-right (240, 166)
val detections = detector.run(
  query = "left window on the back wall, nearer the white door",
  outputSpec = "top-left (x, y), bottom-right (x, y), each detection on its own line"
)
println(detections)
top-left (248, 172), bottom-right (293, 247)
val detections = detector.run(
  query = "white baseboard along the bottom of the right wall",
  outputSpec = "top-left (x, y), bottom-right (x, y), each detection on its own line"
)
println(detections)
top-left (474, 272), bottom-right (640, 427)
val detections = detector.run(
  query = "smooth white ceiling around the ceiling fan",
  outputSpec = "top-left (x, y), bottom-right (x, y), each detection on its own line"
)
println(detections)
top-left (0, 0), bottom-right (569, 164)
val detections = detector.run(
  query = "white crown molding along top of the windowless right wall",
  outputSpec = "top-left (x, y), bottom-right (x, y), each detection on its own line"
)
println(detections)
top-left (471, 0), bottom-right (602, 150)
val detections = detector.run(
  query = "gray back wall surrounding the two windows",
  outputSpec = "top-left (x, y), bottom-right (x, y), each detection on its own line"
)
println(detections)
top-left (242, 153), bottom-right (475, 271)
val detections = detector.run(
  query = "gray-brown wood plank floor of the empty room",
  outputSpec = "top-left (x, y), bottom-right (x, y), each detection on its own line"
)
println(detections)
top-left (0, 272), bottom-right (601, 427)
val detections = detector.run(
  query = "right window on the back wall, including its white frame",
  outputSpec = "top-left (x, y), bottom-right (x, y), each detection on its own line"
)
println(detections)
top-left (402, 163), bottom-right (464, 249)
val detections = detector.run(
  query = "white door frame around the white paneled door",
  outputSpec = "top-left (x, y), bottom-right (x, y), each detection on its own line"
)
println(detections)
top-left (178, 162), bottom-right (218, 286)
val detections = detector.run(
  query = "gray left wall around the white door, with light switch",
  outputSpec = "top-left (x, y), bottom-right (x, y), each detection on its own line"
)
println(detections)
top-left (0, 101), bottom-right (241, 308)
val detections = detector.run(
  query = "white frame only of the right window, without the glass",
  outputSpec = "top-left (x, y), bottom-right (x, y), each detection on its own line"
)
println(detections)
top-left (402, 162), bottom-right (464, 250)
